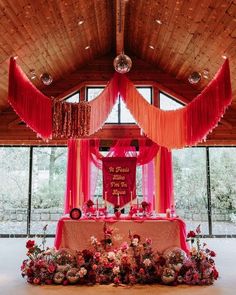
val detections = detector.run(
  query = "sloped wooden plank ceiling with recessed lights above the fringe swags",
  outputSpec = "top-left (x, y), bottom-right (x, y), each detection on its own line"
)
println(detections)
top-left (0, 0), bottom-right (236, 144)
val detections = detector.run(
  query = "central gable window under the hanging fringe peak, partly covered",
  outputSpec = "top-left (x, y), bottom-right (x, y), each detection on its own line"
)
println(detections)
top-left (87, 87), bottom-right (152, 124)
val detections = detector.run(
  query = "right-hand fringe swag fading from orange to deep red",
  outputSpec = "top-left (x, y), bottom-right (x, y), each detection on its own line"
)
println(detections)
top-left (119, 60), bottom-right (232, 149)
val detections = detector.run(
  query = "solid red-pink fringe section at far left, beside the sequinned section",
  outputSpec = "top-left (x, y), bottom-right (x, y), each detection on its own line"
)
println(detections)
top-left (8, 58), bottom-right (52, 139)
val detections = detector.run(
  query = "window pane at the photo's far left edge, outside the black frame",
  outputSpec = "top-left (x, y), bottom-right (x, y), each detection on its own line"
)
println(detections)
top-left (0, 147), bottom-right (29, 235)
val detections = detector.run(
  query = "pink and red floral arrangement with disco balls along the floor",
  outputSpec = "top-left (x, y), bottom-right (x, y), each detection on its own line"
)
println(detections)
top-left (21, 224), bottom-right (218, 286)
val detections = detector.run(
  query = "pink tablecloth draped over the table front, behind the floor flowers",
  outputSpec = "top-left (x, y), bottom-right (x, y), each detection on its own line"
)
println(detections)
top-left (55, 217), bottom-right (188, 252)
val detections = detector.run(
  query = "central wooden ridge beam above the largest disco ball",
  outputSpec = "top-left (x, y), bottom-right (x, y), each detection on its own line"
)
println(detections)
top-left (115, 0), bottom-right (126, 55)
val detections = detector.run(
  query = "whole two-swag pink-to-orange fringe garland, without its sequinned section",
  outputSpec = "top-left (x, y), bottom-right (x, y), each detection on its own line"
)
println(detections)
top-left (9, 59), bottom-right (232, 149)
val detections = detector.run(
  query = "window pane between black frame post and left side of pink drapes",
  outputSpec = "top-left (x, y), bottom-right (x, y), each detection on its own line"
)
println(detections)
top-left (30, 147), bottom-right (67, 234)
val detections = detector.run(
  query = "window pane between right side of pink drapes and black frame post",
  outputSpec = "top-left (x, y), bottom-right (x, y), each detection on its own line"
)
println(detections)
top-left (172, 148), bottom-right (209, 234)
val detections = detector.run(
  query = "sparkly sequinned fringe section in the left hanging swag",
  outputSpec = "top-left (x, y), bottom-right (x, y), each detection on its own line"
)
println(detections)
top-left (53, 100), bottom-right (91, 138)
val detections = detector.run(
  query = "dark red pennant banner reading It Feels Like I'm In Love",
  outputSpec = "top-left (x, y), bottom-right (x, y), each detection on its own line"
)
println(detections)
top-left (103, 157), bottom-right (137, 207)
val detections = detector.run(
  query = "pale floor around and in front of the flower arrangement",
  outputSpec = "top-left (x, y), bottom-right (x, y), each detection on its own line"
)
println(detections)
top-left (0, 239), bottom-right (236, 295)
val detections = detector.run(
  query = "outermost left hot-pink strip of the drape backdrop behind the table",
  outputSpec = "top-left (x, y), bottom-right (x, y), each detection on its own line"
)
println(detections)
top-left (64, 139), bottom-right (77, 214)
